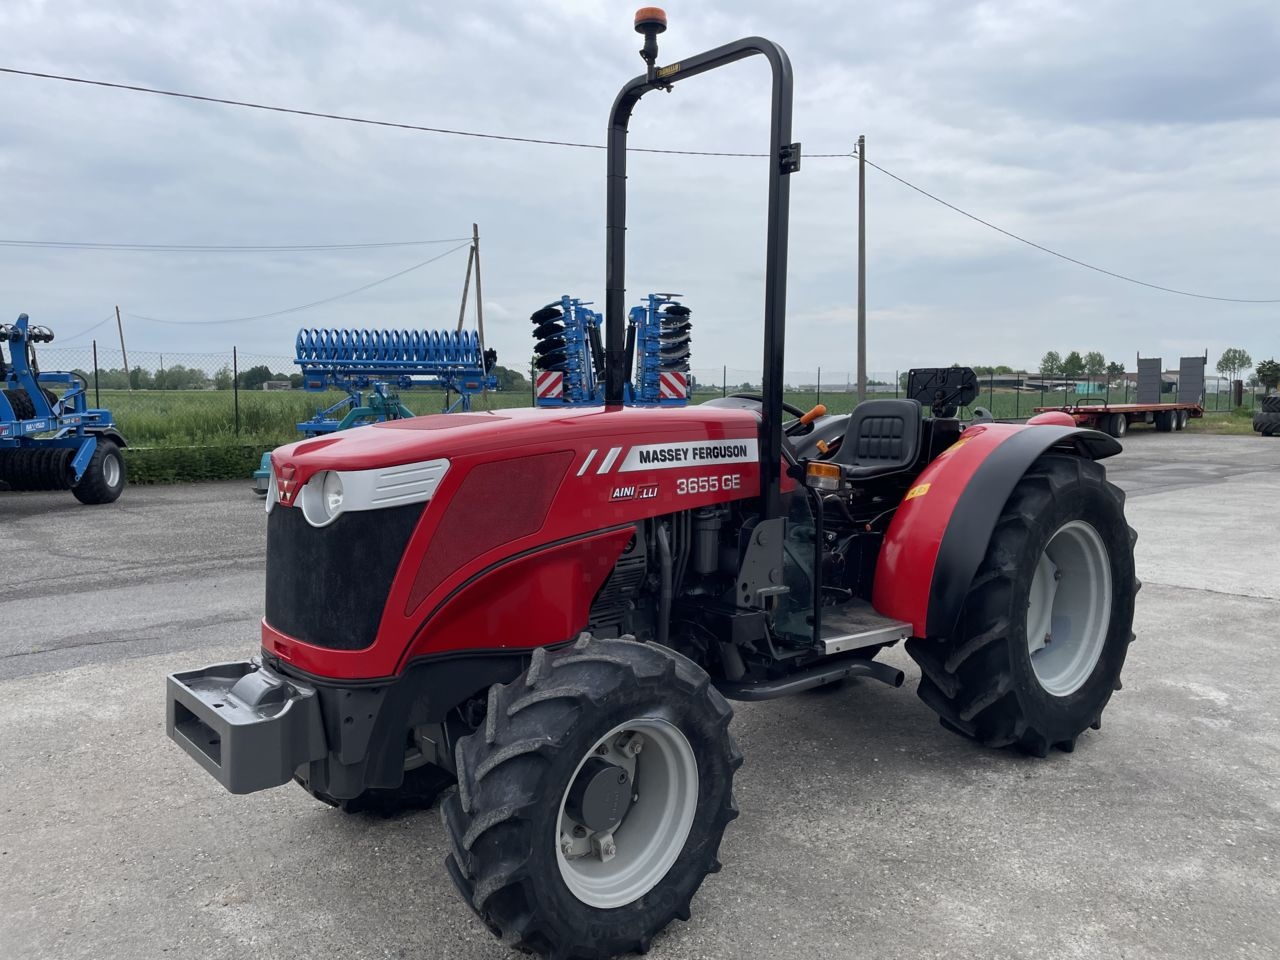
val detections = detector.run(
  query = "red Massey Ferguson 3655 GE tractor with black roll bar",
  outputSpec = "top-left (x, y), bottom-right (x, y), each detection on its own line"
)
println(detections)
top-left (168, 8), bottom-right (1138, 960)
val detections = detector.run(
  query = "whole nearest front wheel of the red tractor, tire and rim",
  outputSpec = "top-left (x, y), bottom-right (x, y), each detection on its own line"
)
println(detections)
top-left (442, 635), bottom-right (742, 960)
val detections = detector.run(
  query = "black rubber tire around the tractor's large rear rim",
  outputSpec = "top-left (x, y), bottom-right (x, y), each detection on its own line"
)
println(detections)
top-left (906, 453), bottom-right (1139, 756)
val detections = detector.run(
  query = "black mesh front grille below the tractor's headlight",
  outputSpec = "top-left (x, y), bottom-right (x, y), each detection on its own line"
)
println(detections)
top-left (266, 503), bottom-right (425, 650)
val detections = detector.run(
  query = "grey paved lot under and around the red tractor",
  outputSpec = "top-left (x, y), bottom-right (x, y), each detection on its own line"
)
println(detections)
top-left (0, 433), bottom-right (1280, 960)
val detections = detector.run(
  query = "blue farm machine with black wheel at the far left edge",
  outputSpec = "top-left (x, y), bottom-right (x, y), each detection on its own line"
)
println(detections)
top-left (0, 314), bottom-right (125, 503)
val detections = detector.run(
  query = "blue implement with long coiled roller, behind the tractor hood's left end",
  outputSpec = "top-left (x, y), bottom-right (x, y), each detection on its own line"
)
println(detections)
top-left (253, 329), bottom-right (498, 494)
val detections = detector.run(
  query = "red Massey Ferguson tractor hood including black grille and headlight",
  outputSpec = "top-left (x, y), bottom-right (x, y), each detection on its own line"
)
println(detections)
top-left (254, 406), bottom-right (760, 678)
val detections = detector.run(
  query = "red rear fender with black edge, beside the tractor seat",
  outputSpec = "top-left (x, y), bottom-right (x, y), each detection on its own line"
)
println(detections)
top-left (872, 424), bottom-right (1121, 637)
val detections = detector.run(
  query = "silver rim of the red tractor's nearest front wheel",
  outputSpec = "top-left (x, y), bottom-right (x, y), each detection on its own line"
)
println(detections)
top-left (553, 717), bottom-right (699, 910)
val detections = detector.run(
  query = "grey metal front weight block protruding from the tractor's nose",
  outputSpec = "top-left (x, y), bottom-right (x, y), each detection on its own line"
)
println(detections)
top-left (165, 660), bottom-right (326, 794)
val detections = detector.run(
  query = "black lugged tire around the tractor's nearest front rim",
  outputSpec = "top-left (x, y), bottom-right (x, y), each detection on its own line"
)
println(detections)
top-left (440, 635), bottom-right (742, 960)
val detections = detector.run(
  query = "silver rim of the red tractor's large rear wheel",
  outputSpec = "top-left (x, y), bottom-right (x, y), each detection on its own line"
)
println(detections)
top-left (1027, 520), bottom-right (1111, 696)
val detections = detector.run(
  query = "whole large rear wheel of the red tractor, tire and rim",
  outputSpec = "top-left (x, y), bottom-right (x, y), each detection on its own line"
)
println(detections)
top-left (906, 454), bottom-right (1139, 756)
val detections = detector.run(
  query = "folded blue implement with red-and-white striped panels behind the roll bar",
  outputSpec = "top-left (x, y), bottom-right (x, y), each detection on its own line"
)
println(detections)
top-left (530, 293), bottom-right (691, 407)
